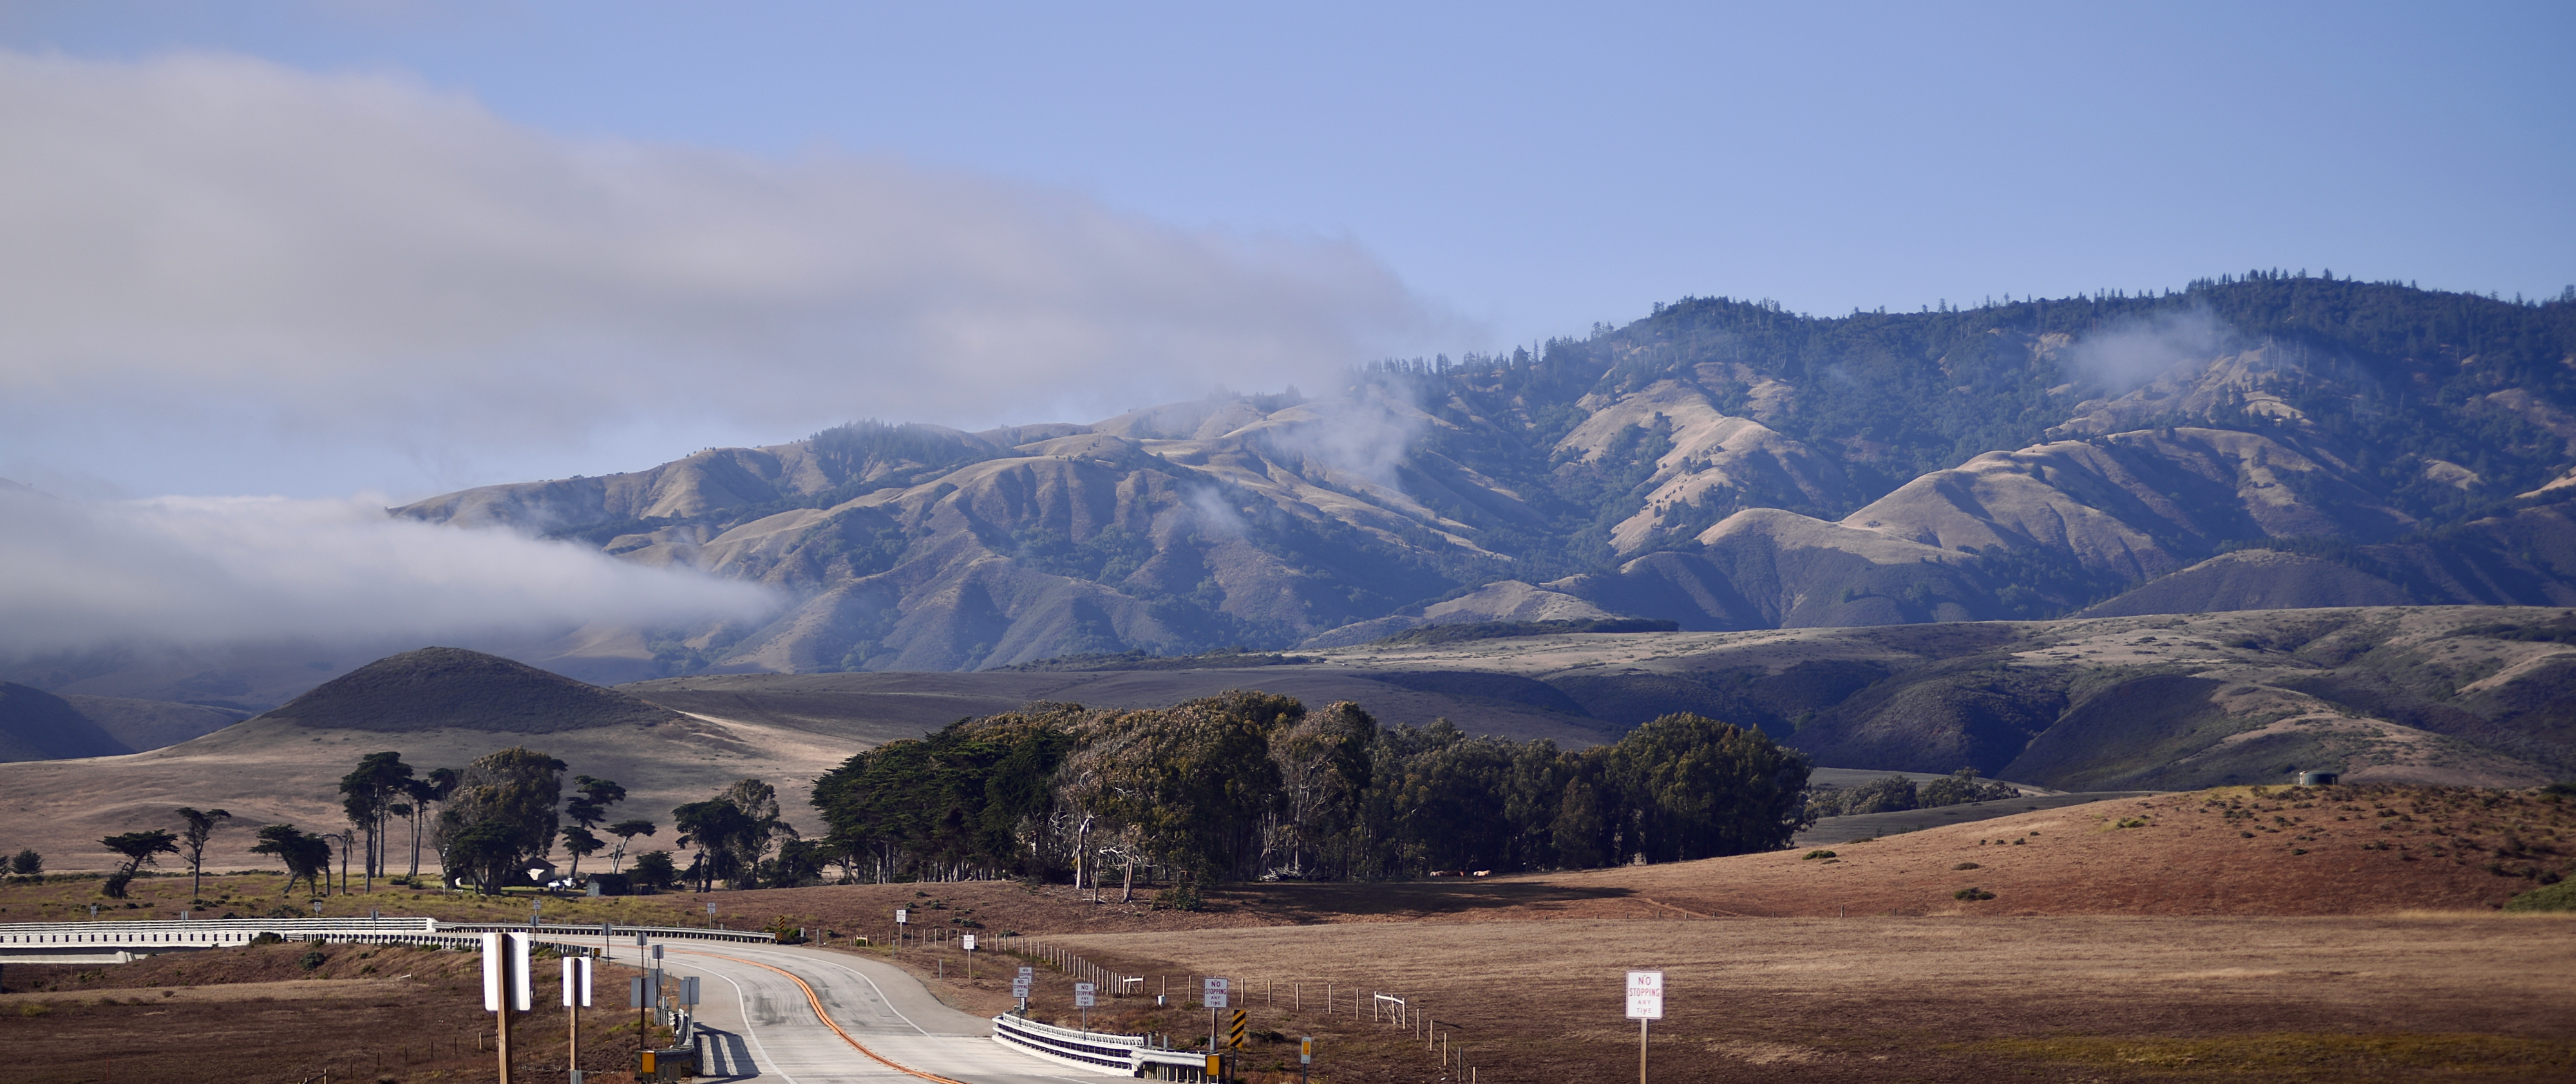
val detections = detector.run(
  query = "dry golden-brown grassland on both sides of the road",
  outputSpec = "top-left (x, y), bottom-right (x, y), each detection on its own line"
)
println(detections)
top-left (0, 788), bottom-right (2576, 1084)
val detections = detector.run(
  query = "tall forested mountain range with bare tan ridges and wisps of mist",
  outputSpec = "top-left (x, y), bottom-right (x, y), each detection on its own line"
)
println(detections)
top-left (399, 273), bottom-right (2576, 677)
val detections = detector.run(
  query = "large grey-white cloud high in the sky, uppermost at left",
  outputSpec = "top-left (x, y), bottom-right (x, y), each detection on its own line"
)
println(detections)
top-left (0, 51), bottom-right (1448, 466)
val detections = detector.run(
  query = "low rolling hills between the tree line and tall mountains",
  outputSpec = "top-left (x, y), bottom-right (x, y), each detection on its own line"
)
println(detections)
top-left (0, 608), bottom-right (2576, 868)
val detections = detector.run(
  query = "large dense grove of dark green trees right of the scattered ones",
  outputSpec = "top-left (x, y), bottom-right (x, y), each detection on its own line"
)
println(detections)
top-left (793, 693), bottom-right (1808, 904)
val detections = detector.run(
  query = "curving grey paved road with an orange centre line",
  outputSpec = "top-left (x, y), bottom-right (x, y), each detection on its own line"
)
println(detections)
top-left (662, 945), bottom-right (1110, 1084)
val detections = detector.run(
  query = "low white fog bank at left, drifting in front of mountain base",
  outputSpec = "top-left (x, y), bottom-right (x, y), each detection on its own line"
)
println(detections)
top-left (0, 484), bottom-right (778, 657)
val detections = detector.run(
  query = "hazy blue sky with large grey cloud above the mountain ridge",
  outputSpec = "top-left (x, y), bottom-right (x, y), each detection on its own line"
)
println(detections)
top-left (0, 3), bottom-right (2576, 494)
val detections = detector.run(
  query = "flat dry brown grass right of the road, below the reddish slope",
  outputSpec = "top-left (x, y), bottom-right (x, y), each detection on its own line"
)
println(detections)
top-left (1036, 917), bottom-right (2576, 1084)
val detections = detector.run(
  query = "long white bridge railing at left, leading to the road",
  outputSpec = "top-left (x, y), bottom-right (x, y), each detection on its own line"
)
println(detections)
top-left (0, 917), bottom-right (778, 963)
